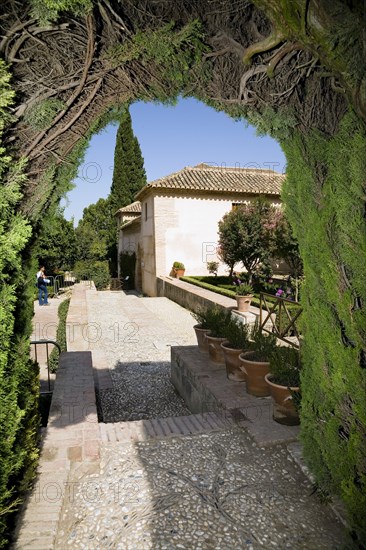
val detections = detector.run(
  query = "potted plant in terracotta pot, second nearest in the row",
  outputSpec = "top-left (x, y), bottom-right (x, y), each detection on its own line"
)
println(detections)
top-left (239, 321), bottom-right (277, 397)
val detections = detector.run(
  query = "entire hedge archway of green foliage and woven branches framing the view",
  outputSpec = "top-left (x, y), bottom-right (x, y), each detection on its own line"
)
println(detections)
top-left (0, 0), bottom-right (366, 540)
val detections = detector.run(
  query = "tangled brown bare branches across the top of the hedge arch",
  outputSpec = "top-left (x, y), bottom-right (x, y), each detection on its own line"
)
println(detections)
top-left (0, 0), bottom-right (364, 211)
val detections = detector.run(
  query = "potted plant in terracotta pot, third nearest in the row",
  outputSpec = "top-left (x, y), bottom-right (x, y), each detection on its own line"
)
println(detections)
top-left (221, 316), bottom-right (249, 382)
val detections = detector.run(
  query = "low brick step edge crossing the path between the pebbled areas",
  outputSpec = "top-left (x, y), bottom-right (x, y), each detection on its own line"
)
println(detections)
top-left (99, 412), bottom-right (234, 443)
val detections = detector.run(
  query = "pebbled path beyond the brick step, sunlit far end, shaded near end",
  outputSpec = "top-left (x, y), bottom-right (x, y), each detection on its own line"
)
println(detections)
top-left (87, 292), bottom-right (196, 422)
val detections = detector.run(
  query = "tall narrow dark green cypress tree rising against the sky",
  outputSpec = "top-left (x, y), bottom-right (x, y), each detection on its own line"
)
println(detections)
top-left (110, 108), bottom-right (146, 212)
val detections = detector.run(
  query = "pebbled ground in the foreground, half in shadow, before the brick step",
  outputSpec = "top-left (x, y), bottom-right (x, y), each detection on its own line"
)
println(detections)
top-left (56, 429), bottom-right (342, 550)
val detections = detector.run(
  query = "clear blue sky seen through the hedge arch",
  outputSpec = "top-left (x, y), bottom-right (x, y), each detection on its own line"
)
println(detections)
top-left (61, 98), bottom-right (286, 225)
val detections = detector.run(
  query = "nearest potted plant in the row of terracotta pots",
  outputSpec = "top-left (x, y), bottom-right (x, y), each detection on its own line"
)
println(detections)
top-left (265, 347), bottom-right (301, 426)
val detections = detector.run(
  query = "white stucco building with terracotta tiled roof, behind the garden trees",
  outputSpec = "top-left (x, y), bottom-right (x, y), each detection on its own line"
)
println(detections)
top-left (117, 164), bottom-right (285, 296)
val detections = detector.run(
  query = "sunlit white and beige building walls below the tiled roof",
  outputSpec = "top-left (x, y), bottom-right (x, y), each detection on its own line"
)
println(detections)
top-left (126, 193), bottom-right (280, 296)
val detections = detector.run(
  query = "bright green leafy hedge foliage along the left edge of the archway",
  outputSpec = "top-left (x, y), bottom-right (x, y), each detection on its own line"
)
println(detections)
top-left (0, 59), bottom-right (39, 547)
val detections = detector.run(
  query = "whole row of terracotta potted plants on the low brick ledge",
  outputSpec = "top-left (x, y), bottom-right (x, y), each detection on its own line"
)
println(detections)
top-left (193, 306), bottom-right (301, 425)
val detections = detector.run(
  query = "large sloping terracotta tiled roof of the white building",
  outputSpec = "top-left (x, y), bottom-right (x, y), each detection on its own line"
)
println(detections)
top-left (136, 164), bottom-right (285, 199)
